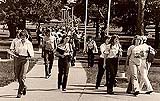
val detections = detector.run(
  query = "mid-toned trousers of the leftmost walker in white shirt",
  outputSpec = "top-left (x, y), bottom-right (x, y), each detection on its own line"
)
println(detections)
top-left (15, 57), bottom-right (29, 94)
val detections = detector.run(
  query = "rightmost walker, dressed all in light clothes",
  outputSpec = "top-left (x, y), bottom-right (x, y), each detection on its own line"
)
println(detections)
top-left (139, 36), bottom-right (155, 94)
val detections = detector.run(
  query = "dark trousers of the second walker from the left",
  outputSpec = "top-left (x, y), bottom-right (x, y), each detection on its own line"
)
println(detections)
top-left (44, 50), bottom-right (54, 76)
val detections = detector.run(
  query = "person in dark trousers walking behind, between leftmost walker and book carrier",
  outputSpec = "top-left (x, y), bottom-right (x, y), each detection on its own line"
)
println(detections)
top-left (43, 29), bottom-right (57, 79)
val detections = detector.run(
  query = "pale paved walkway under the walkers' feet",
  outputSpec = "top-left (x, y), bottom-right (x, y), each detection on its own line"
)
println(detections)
top-left (0, 51), bottom-right (160, 101)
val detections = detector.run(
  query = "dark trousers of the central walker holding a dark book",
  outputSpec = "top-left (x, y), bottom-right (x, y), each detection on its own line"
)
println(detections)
top-left (58, 56), bottom-right (69, 89)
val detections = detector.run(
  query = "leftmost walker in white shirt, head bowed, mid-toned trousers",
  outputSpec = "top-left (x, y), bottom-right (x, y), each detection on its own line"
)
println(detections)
top-left (11, 30), bottom-right (34, 98)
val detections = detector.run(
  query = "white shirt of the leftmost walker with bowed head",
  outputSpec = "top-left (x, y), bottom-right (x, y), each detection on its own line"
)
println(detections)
top-left (15, 39), bottom-right (34, 57)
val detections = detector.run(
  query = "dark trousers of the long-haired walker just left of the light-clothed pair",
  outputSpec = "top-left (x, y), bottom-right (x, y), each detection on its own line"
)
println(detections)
top-left (106, 58), bottom-right (118, 92)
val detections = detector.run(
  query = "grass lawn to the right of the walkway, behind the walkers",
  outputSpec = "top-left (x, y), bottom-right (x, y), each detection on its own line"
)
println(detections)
top-left (82, 63), bottom-right (160, 93)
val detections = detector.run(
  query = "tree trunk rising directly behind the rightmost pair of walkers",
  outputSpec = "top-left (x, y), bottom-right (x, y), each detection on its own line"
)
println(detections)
top-left (137, 0), bottom-right (146, 35)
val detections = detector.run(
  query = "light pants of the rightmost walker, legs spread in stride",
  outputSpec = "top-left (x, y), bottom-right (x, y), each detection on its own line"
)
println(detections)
top-left (139, 60), bottom-right (153, 91)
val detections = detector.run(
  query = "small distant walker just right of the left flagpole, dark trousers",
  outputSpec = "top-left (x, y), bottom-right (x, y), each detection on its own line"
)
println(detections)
top-left (83, 36), bottom-right (98, 67)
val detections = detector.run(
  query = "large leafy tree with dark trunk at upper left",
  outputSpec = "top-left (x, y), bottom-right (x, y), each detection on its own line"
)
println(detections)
top-left (0, 0), bottom-right (63, 38)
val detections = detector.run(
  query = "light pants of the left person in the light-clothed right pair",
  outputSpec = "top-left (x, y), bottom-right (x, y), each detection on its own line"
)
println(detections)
top-left (129, 61), bottom-right (139, 92)
